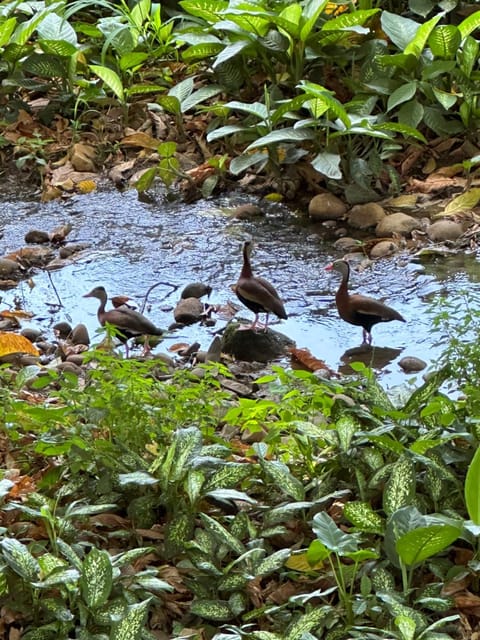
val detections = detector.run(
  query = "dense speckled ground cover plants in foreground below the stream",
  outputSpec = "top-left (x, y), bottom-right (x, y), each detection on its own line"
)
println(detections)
top-left (0, 302), bottom-right (480, 640)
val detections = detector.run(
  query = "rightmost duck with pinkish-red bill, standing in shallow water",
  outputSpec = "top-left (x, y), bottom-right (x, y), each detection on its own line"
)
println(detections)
top-left (326, 260), bottom-right (405, 344)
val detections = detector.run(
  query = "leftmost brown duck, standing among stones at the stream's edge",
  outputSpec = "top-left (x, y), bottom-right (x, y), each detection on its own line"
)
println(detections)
top-left (83, 287), bottom-right (163, 358)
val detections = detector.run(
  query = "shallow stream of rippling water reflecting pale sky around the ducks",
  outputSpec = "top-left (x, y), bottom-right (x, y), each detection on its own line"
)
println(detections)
top-left (0, 190), bottom-right (480, 386)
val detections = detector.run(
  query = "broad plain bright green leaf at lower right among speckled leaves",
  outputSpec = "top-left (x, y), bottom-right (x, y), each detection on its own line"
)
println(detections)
top-left (396, 524), bottom-right (461, 566)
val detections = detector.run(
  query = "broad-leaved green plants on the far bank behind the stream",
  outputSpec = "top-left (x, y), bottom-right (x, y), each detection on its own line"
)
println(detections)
top-left (0, 0), bottom-right (480, 201)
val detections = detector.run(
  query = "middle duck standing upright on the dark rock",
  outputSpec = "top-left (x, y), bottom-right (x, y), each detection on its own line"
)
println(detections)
top-left (233, 240), bottom-right (288, 331)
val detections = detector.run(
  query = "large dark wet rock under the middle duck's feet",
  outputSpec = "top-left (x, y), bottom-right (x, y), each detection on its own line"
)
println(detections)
top-left (222, 322), bottom-right (295, 362)
